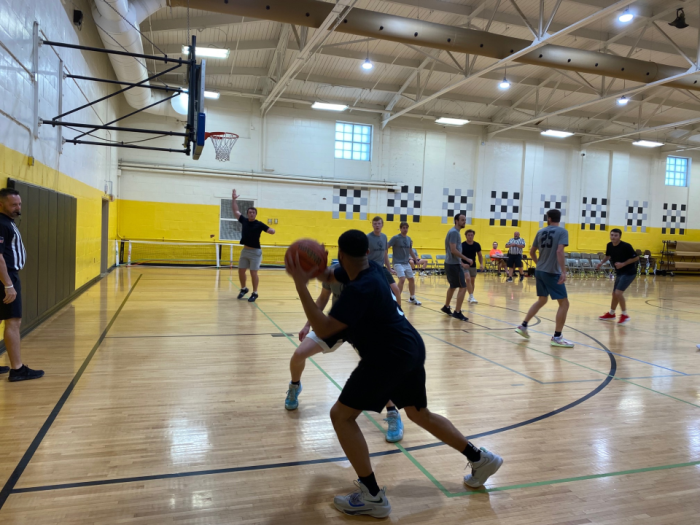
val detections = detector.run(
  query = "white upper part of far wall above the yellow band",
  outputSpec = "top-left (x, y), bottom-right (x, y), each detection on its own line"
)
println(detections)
top-left (120, 96), bottom-right (700, 229)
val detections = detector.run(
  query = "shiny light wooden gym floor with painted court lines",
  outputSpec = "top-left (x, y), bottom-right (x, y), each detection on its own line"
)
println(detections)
top-left (0, 267), bottom-right (700, 525)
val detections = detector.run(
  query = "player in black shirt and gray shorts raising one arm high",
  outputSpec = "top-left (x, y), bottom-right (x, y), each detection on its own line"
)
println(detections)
top-left (231, 189), bottom-right (275, 303)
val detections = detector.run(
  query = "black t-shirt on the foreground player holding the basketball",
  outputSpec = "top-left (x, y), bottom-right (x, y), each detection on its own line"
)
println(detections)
top-left (330, 261), bottom-right (425, 370)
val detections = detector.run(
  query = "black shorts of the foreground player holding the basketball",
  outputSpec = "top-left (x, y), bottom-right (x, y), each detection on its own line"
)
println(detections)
top-left (338, 360), bottom-right (428, 412)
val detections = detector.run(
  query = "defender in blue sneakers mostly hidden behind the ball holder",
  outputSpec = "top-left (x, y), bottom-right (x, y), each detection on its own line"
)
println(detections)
top-left (284, 265), bottom-right (403, 443)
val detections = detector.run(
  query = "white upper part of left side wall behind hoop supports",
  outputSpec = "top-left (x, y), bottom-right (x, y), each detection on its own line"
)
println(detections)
top-left (0, 0), bottom-right (117, 189)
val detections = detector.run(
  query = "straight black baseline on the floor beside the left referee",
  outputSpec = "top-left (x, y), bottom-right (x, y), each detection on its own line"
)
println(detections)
top-left (0, 275), bottom-right (141, 510)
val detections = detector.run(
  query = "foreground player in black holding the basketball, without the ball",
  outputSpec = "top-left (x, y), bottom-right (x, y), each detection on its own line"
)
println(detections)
top-left (287, 230), bottom-right (503, 518)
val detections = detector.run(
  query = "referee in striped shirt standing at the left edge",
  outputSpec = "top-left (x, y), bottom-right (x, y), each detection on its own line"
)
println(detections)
top-left (0, 188), bottom-right (44, 382)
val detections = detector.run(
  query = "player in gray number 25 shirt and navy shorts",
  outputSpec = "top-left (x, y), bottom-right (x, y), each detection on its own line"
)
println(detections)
top-left (515, 210), bottom-right (574, 348)
